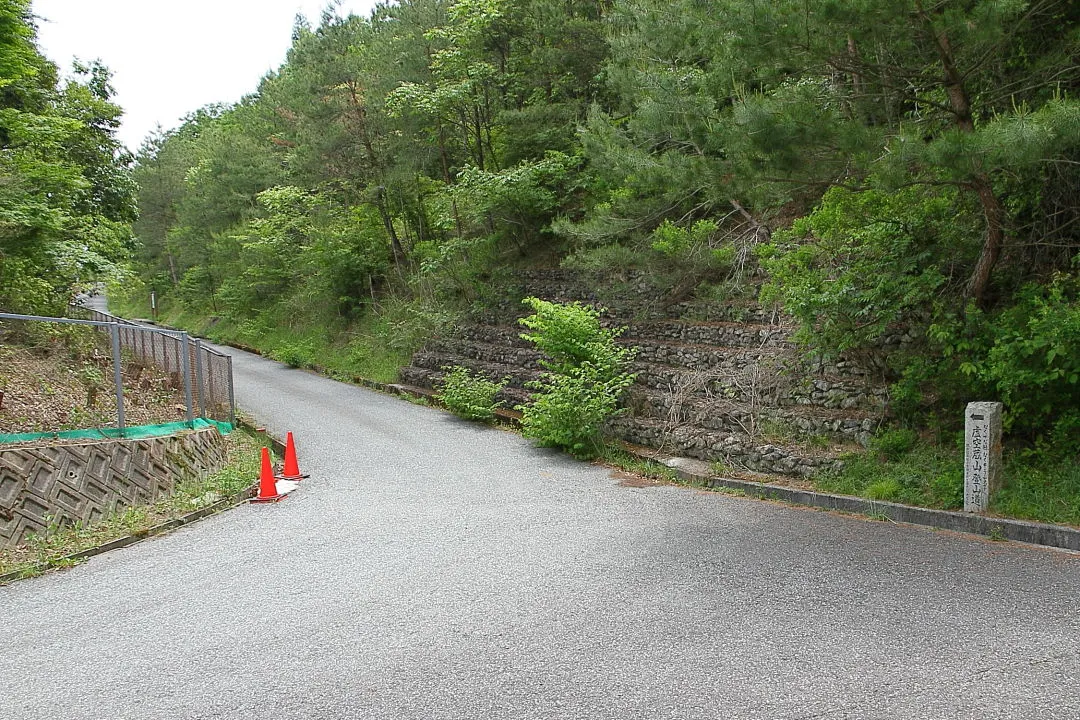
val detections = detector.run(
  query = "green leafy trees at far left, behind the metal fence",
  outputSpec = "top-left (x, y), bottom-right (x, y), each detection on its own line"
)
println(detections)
top-left (0, 0), bottom-right (137, 314)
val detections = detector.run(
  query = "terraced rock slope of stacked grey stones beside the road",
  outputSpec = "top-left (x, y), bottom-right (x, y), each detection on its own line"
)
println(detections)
top-left (401, 270), bottom-right (889, 476)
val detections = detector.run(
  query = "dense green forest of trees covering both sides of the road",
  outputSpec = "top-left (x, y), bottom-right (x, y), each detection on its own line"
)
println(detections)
top-left (6, 0), bottom-right (1080, 459)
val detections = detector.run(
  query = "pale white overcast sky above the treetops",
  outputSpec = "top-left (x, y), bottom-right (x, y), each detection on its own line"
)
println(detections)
top-left (32, 0), bottom-right (375, 151)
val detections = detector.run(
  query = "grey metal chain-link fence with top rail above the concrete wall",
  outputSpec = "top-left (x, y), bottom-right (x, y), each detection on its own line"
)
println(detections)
top-left (0, 305), bottom-right (237, 432)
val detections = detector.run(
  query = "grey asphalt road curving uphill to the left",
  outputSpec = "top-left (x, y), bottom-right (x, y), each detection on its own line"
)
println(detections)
top-left (0, 345), bottom-right (1080, 720)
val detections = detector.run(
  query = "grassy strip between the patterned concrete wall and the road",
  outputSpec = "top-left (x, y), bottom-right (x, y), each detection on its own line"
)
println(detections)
top-left (0, 430), bottom-right (261, 578)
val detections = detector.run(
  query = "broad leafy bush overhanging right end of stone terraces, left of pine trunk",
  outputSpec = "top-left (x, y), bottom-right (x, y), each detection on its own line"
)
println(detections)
top-left (758, 188), bottom-right (977, 356)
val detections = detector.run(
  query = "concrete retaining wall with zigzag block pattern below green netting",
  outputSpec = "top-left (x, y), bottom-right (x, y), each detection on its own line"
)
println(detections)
top-left (0, 429), bottom-right (225, 548)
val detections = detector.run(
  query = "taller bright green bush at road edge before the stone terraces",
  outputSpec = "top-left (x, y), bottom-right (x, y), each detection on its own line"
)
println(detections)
top-left (517, 298), bottom-right (635, 457)
